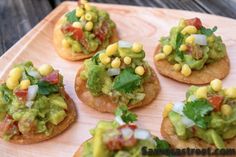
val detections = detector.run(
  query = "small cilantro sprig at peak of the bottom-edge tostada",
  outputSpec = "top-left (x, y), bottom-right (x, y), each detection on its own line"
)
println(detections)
top-left (115, 105), bottom-right (137, 124)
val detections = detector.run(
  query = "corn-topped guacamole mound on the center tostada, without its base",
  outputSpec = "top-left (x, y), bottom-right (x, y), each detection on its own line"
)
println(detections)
top-left (80, 41), bottom-right (151, 105)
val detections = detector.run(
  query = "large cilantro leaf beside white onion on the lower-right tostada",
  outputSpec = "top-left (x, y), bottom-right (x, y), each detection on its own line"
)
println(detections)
top-left (183, 99), bottom-right (213, 129)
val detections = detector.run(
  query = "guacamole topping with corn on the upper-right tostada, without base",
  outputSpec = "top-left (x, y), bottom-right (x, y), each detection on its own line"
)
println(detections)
top-left (155, 18), bottom-right (226, 77)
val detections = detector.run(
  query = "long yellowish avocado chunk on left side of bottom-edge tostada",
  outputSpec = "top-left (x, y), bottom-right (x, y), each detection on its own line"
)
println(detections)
top-left (93, 121), bottom-right (113, 157)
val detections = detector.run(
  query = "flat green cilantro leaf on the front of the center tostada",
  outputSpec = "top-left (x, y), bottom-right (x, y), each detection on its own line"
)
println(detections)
top-left (113, 68), bottom-right (141, 93)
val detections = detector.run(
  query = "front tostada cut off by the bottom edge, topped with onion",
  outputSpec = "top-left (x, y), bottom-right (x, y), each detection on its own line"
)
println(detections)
top-left (74, 106), bottom-right (169, 157)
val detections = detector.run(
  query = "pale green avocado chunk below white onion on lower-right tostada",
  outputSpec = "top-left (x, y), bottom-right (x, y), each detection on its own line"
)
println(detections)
top-left (168, 111), bottom-right (188, 139)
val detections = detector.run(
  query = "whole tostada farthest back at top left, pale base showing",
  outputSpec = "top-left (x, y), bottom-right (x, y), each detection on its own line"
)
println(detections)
top-left (53, 1), bottom-right (118, 61)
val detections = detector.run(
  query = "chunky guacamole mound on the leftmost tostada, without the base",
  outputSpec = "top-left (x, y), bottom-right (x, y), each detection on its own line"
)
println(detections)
top-left (0, 62), bottom-right (67, 140)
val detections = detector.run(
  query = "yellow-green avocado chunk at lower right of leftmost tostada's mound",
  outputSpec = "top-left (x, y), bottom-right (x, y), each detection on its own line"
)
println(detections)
top-left (49, 110), bottom-right (66, 125)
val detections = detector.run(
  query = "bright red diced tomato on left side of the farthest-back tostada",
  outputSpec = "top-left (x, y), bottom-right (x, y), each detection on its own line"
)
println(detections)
top-left (62, 24), bottom-right (83, 41)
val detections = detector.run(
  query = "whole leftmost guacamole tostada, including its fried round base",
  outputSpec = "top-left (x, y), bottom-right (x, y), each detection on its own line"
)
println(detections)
top-left (0, 62), bottom-right (76, 144)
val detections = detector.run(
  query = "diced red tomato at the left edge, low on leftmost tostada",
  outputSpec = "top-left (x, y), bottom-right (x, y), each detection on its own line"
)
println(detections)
top-left (0, 115), bottom-right (18, 136)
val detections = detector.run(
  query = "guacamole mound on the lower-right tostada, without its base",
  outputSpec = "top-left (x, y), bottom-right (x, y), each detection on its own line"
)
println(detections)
top-left (168, 81), bottom-right (236, 148)
